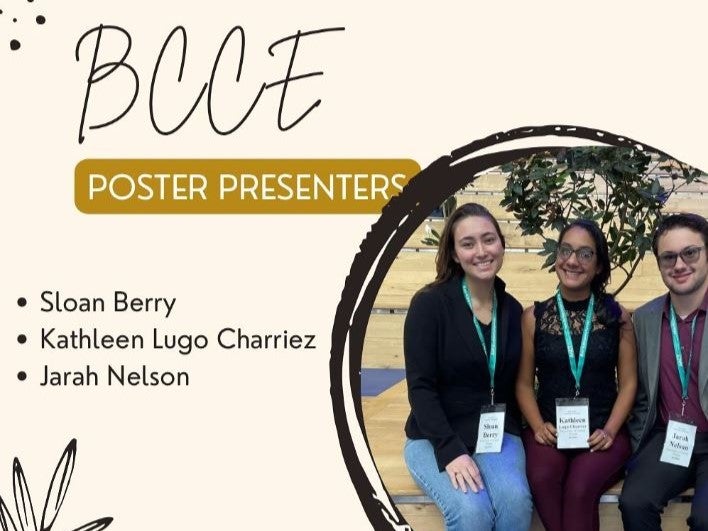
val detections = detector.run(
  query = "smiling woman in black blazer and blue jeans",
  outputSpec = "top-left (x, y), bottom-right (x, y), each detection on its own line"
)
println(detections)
top-left (404, 203), bottom-right (533, 531)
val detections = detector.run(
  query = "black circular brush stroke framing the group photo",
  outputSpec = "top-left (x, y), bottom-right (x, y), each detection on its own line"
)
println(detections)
top-left (330, 125), bottom-right (668, 530)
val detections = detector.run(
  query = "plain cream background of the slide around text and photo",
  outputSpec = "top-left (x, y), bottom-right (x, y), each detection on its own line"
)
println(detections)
top-left (0, 0), bottom-right (708, 531)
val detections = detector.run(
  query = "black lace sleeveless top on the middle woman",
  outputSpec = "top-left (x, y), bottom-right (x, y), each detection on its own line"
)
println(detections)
top-left (534, 296), bottom-right (621, 433)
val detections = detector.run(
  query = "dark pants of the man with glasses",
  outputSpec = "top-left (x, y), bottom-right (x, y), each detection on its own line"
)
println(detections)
top-left (619, 429), bottom-right (708, 531)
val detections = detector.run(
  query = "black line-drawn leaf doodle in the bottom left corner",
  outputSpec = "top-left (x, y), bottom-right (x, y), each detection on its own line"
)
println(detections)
top-left (0, 442), bottom-right (113, 531)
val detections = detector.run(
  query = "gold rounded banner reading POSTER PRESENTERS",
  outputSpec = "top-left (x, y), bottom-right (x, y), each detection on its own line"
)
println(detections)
top-left (74, 159), bottom-right (420, 214)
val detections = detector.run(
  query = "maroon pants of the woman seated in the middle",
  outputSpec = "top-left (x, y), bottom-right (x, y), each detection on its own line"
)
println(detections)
top-left (522, 428), bottom-right (632, 531)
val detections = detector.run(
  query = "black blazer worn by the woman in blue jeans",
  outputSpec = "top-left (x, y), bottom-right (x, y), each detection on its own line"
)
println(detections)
top-left (403, 276), bottom-right (522, 471)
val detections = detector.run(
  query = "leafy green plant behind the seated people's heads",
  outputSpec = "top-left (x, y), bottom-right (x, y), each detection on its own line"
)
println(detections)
top-left (501, 146), bottom-right (704, 295)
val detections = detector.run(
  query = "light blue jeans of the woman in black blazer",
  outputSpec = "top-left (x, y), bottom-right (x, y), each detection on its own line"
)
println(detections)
top-left (403, 433), bottom-right (533, 531)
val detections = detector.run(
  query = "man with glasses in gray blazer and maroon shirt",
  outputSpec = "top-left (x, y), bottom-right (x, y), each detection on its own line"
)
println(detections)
top-left (619, 214), bottom-right (708, 531)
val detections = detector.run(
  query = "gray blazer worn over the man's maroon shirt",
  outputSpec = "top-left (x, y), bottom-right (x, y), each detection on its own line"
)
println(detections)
top-left (627, 295), bottom-right (708, 452)
